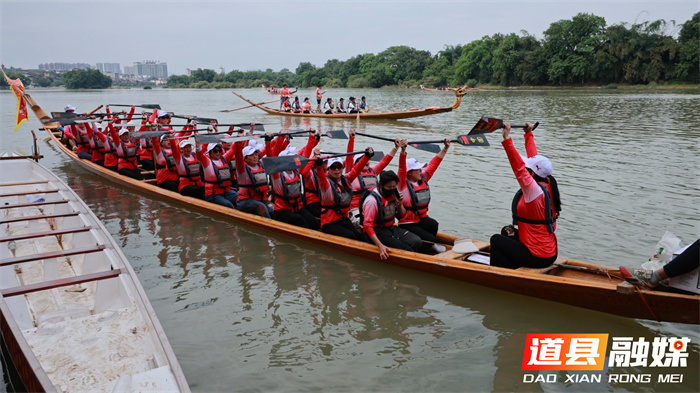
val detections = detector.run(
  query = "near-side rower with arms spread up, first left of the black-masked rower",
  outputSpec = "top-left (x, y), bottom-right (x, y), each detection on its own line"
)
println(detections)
top-left (316, 147), bottom-right (374, 240)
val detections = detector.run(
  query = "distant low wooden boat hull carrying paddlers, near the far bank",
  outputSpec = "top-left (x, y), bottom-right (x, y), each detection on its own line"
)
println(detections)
top-left (233, 88), bottom-right (467, 120)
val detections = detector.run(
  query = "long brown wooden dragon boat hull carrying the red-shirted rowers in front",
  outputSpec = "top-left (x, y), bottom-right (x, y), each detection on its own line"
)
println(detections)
top-left (27, 92), bottom-right (700, 324)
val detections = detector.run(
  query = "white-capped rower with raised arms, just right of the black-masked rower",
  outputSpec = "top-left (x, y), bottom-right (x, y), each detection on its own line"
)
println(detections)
top-left (398, 138), bottom-right (450, 254)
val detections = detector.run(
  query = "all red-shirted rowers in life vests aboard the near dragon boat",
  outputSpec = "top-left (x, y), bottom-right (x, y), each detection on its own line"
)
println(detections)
top-left (62, 105), bottom-right (560, 268)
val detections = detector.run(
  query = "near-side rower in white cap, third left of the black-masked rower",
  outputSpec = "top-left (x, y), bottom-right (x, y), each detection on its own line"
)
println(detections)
top-left (232, 135), bottom-right (274, 218)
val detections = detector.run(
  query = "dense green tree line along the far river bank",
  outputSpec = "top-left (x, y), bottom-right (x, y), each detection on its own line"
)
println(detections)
top-left (168, 12), bottom-right (700, 88)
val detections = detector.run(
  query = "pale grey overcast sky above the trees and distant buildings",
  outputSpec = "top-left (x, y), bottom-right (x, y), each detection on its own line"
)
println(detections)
top-left (0, 0), bottom-right (700, 75)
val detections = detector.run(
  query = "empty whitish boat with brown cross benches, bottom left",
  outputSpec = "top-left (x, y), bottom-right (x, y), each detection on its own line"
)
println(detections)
top-left (0, 152), bottom-right (190, 392)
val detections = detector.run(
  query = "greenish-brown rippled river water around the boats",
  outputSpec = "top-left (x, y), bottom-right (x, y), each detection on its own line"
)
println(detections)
top-left (0, 89), bottom-right (700, 392)
